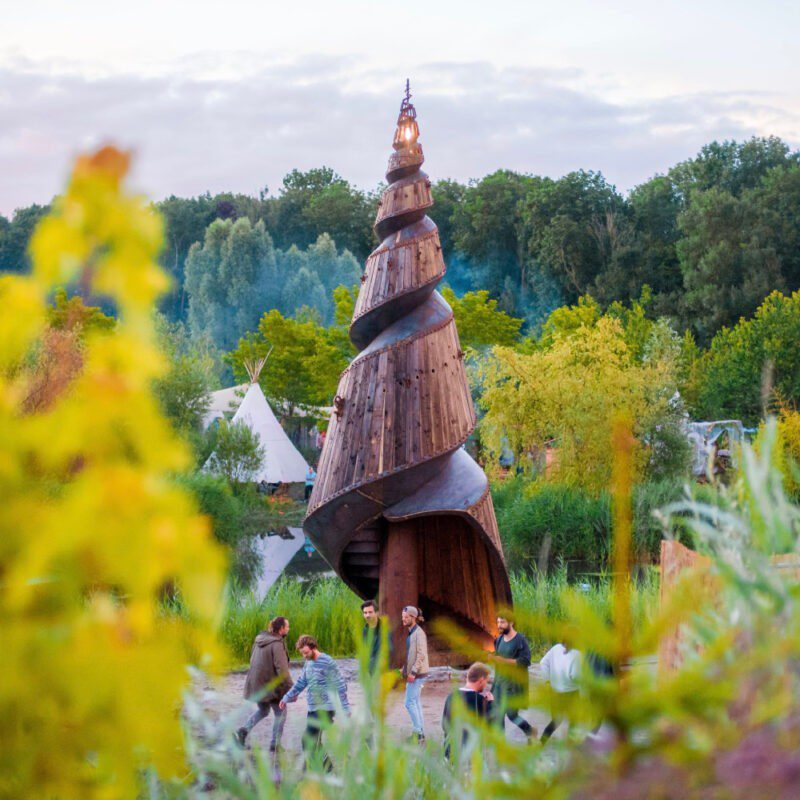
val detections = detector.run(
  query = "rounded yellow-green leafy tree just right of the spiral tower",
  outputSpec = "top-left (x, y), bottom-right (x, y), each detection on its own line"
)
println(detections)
top-left (481, 316), bottom-right (675, 490)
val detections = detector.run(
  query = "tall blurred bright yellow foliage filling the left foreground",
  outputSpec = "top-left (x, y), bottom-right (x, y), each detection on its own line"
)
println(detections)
top-left (0, 148), bottom-right (224, 798)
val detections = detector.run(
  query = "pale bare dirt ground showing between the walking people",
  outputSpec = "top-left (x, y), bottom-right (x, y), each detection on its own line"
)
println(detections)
top-left (196, 659), bottom-right (549, 754)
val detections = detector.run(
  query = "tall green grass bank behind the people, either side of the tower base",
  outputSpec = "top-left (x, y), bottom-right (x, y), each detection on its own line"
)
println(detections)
top-left (222, 570), bottom-right (658, 662)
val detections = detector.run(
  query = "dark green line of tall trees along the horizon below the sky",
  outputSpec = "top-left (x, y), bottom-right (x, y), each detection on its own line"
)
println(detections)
top-left (0, 137), bottom-right (800, 345)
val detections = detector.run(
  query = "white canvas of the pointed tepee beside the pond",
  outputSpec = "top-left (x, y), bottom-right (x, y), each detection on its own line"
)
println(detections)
top-left (206, 383), bottom-right (308, 483)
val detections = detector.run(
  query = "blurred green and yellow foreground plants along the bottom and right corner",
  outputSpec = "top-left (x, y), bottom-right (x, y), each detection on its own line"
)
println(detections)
top-left (170, 420), bottom-right (800, 800)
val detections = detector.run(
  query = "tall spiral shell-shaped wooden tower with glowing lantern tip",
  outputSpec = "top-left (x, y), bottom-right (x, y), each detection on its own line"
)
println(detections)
top-left (304, 83), bottom-right (511, 664)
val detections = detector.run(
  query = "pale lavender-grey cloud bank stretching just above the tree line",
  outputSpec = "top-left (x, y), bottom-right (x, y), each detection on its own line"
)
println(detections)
top-left (0, 54), bottom-right (800, 214)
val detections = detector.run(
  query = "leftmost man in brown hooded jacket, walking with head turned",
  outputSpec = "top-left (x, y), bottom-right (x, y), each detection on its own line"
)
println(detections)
top-left (236, 617), bottom-right (292, 753)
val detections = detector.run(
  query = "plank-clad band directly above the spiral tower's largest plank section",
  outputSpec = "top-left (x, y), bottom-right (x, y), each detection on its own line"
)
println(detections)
top-left (353, 231), bottom-right (445, 321)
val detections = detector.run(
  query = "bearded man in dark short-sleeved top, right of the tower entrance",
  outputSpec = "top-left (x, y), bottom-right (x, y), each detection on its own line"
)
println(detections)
top-left (492, 617), bottom-right (536, 738)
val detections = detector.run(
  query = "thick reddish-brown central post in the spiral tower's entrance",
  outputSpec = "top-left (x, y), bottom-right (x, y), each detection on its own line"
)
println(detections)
top-left (378, 520), bottom-right (419, 667)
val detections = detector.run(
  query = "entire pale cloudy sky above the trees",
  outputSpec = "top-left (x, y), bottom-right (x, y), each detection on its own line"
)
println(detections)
top-left (0, 0), bottom-right (800, 216)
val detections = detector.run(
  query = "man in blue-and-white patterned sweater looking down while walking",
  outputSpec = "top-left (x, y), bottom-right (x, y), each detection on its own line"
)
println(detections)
top-left (280, 635), bottom-right (350, 772)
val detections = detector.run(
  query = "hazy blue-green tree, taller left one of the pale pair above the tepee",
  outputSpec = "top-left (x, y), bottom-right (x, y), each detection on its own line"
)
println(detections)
top-left (186, 218), bottom-right (278, 350)
